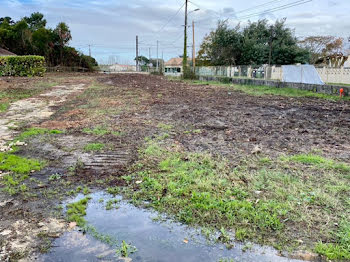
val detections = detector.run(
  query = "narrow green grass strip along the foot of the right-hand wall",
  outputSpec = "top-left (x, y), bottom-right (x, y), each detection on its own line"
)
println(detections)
top-left (187, 80), bottom-right (350, 101)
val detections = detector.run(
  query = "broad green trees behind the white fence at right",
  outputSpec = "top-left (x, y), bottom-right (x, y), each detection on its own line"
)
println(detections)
top-left (197, 19), bottom-right (343, 66)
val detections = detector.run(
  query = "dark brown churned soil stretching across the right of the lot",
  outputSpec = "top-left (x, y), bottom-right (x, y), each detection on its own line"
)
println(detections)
top-left (95, 75), bottom-right (350, 160)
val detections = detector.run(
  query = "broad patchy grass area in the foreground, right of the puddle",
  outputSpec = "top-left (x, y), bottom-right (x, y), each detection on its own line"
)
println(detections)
top-left (130, 141), bottom-right (350, 259)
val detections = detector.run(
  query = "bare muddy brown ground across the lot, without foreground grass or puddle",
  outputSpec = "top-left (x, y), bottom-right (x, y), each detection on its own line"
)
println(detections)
top-left (0, 74), bottom-right (350, 261)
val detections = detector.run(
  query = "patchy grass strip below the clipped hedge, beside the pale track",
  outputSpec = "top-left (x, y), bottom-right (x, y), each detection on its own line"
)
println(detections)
top-left (0, 81), bottom-right (56, 113)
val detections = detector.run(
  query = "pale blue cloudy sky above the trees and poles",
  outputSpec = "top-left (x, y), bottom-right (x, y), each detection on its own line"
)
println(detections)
top-left (0, 0), bottom-right (350, 63)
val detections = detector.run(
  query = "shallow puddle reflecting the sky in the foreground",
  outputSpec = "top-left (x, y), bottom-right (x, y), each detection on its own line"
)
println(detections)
top-left (39, 192), bottom-right (300, 262)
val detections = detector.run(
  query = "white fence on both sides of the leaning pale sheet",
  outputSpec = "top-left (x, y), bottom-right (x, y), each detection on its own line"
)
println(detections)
top-left (196, 65), bottom-right (350, 84)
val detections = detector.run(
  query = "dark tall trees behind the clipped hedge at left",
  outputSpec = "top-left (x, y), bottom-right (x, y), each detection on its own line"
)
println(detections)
top-left (0, 12), bottom-right (97, 70)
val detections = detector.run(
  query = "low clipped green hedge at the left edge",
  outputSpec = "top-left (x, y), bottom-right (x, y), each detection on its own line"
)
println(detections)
top-left (0, 56), bottom-right (45, 76)
